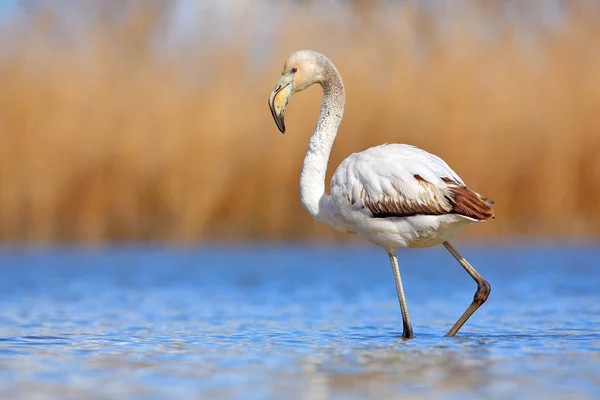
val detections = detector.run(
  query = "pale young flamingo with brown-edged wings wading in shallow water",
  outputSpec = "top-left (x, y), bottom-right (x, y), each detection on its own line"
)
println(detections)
top-left (269, 50), bottom-right (494, 339)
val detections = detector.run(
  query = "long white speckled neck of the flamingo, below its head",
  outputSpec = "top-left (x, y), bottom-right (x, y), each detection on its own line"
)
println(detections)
top-left (300, 64), bottom-right (345, 220)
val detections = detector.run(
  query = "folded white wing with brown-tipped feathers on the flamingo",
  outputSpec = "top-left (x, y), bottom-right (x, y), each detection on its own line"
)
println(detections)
top-left (331, 144), bottom-right (494, 221)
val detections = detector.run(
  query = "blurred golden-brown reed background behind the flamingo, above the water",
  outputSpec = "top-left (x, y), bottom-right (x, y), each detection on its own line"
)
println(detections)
top-left (0, 0), bottom-right (600, 243)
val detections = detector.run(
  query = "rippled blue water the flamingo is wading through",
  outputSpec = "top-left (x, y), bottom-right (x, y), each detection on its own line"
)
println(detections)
top-left (0, 245), bottom-right (600, 399)
